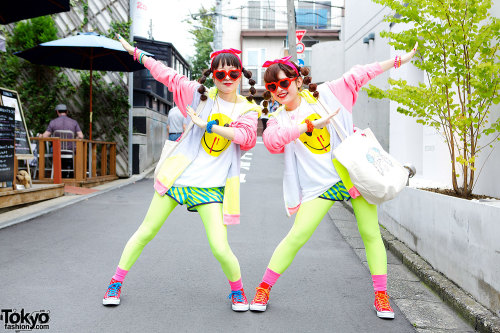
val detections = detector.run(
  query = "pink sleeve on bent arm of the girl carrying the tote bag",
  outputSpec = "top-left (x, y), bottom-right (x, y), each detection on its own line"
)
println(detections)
top-left (262, 116), bottom-right (300, 154)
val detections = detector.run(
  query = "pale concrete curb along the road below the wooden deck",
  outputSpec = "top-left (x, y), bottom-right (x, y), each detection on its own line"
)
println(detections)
top-left (0, 166), bottom-right (155, 229)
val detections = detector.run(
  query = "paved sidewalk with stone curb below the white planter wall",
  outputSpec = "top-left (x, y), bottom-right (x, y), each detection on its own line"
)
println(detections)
top-left (328, 202), bottom-right (500, 333)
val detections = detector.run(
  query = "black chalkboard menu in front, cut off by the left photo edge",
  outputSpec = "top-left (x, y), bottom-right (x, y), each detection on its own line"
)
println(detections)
top-left (0, 106), bottom-right (16, 182)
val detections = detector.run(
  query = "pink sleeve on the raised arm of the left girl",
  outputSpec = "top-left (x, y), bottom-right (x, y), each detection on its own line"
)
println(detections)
top-left (144, 58), bottom-right (200, 117)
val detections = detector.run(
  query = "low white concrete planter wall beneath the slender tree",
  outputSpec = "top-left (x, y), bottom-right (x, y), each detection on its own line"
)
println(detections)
top-left (379, 187), bottom-right (500, 315)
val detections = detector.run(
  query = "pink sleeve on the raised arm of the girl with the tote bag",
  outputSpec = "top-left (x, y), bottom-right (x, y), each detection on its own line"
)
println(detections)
top-left (326, 62), bottom-right (383, 112)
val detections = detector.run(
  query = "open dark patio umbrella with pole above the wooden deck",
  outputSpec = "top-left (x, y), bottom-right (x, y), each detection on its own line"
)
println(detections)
top-left (14, 32), bottom-right (153, 140)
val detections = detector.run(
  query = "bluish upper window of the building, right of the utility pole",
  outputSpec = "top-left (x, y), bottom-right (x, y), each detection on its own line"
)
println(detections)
top-left (296, 1), bottom-right (331, 29)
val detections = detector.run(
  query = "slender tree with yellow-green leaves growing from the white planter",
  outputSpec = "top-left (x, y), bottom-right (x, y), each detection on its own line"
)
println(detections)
top-left (366, 0), bottom-right (500, 197)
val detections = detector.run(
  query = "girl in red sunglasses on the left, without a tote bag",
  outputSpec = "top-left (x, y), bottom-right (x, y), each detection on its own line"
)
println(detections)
top-left (103, 35), bottom-right (261, 311)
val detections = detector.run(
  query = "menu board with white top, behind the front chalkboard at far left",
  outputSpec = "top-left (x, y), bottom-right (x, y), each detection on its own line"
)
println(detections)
top-left (0, 88), bottom-right (33, 159)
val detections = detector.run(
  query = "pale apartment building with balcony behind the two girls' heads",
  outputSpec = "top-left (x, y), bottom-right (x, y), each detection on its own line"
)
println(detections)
top-left (221, 0), bottom-right (343, 96)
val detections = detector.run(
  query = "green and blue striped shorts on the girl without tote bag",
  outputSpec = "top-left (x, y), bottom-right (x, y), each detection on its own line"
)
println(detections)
top-left (166, 186), bottom-right (224, 212)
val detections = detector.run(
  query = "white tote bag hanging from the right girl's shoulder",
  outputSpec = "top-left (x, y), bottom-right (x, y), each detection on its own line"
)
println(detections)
top-left (332, 109), bottom-right (408, 205)
